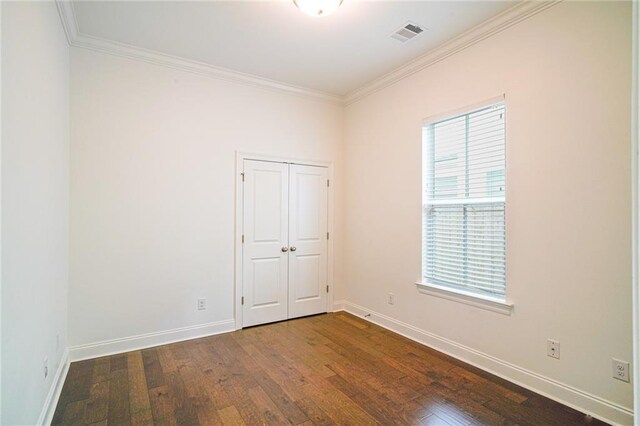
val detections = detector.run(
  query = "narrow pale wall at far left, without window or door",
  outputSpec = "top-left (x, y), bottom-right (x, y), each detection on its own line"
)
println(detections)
top-left (1, 2), bottom-right (69, 425)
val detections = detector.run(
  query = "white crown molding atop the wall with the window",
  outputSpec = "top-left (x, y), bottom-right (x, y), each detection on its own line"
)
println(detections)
top-left (343, 0), bottom-right (562, 105)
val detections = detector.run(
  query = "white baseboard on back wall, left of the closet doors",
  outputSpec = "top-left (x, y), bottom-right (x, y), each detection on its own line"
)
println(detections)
top-left (69, 319), bottom-right (236, 362)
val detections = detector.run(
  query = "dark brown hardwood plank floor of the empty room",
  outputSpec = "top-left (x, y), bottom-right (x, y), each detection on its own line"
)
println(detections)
top-left (53, 313), bottom-right (603, 425)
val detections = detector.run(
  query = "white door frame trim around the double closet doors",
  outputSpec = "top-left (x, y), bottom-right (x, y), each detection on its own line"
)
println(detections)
top-left (233, 151), bottom-right (335, 330)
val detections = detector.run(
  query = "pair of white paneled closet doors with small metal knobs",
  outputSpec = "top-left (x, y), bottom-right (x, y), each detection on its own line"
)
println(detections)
top-left (242, 160), bottom-right (328, 327)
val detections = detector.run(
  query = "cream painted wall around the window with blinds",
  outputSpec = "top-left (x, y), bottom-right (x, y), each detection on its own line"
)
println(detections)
top-left (344, 2), bottom-right (632, 422)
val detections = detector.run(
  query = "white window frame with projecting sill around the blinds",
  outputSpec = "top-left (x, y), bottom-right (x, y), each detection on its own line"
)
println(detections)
top-left (416, 95), bottom-right (513, 315)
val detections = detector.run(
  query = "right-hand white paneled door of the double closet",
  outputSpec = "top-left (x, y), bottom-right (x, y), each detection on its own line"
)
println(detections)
top-left (289, 164), bottom-right (328, 318)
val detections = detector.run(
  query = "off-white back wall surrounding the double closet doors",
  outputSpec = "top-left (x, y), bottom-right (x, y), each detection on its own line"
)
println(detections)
top-left (69, 48), bottom-right (342, 352)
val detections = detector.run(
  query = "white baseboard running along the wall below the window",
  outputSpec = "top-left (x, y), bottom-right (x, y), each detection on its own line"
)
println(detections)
top-left (334, 300), bottom-right (634, 425)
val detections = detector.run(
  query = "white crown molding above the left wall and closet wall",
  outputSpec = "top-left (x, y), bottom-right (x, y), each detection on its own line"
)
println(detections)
top-left (56, 0), bottom-right (342, 104)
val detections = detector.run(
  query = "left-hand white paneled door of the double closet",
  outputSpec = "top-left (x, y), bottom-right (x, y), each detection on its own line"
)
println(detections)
top-left (242, 160), bottom-right (289, 327)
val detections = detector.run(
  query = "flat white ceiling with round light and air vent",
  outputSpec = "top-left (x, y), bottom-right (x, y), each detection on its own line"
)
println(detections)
top-left (73, 0), bottom-right (516, 96)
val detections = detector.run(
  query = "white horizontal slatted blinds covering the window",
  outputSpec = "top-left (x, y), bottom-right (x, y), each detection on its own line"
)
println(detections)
top-left (423, 102), bottom-right (505, 299)
